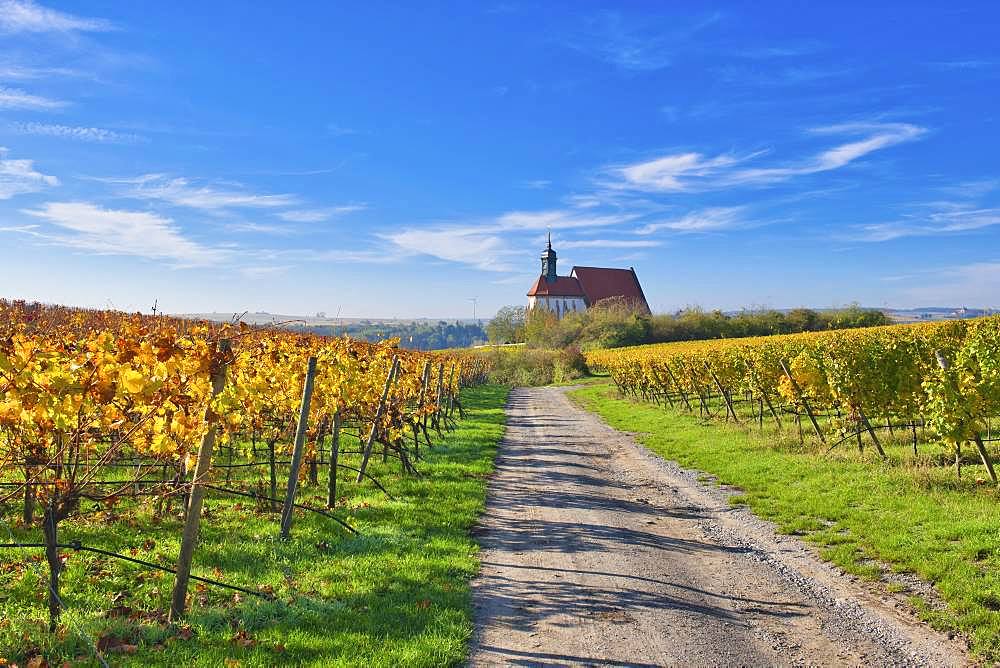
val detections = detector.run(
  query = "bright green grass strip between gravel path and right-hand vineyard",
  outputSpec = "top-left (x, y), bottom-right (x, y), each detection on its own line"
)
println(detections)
top-left (573, 385), bottom-right (1000, 662)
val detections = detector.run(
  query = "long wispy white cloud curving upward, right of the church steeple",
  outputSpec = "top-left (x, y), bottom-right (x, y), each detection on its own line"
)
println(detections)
top-left (608, 123), bottom-right (926, 192)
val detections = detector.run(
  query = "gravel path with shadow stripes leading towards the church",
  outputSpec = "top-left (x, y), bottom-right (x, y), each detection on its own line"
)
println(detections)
top-left (470, 388), bottom-right (968, 666)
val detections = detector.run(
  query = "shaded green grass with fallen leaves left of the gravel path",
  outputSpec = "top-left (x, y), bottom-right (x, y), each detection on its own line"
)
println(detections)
top-left (0, 386), bottom-right (507, 667)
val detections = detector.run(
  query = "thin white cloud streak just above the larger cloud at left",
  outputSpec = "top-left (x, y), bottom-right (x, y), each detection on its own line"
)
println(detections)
top-left (95, 174), bottom-right (298, 212)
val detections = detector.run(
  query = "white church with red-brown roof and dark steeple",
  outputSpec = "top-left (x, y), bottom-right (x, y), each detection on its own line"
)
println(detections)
top-left (528, 234), bottom-right (649, 318)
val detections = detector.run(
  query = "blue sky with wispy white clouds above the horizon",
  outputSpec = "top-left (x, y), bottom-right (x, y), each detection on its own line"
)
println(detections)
top-left (0, 0), bottom-right (1000, 317)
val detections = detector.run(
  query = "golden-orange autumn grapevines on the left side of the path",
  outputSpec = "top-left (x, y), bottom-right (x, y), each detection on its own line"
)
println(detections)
top-left (0, 301), bottom-right (487, 656)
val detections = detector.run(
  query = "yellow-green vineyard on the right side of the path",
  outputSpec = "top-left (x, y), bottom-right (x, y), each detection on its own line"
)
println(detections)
top-left (587, 317), bottom-right (1000, 483)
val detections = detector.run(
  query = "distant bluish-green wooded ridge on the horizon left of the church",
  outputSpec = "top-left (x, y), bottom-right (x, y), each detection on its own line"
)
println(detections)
top-left (296, 320), bottom-right (487, 350)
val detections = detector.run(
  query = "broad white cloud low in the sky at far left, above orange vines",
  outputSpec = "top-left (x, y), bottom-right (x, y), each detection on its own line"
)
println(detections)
top-left (22, 202), bottom-right (228, 266)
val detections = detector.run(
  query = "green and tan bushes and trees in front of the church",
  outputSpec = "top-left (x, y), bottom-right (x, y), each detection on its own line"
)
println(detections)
top-left (486, 299), bottom-right (891, 350)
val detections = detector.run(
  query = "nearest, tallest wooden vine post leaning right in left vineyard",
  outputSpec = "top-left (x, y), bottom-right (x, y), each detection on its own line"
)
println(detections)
top-left (168, 339), bottom-right (232, 622)
